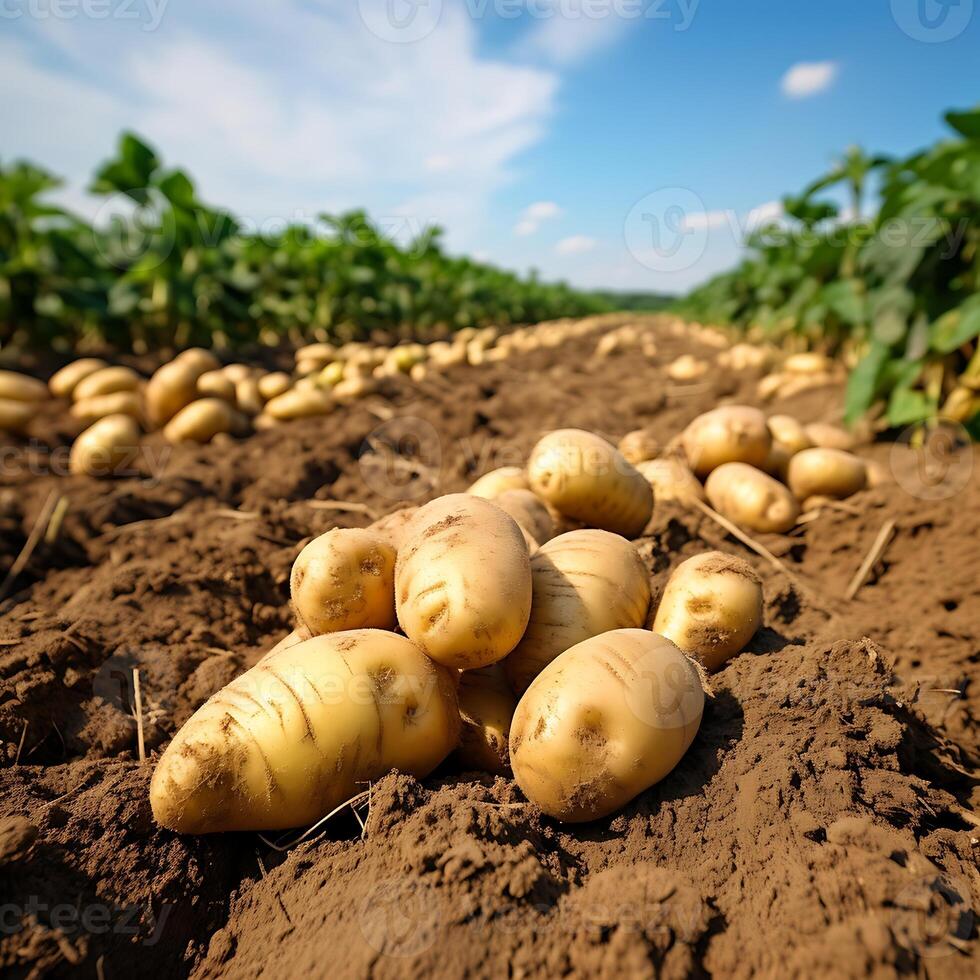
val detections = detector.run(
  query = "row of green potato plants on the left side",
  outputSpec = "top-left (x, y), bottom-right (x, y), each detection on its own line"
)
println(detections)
top-left (0, 133), bottom-right (610, 350)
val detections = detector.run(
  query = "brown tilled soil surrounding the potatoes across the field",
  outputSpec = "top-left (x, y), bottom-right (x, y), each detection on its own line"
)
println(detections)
top-left (0, 317), bottom-right (980, 978)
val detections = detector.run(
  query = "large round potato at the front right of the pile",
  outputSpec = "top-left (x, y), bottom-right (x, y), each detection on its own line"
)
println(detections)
top-left (510, 629), bottom-right (704, 823)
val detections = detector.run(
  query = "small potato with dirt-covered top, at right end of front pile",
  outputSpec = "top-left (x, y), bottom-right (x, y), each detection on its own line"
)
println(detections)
top-left (653, 551), bottom-right (762, 670)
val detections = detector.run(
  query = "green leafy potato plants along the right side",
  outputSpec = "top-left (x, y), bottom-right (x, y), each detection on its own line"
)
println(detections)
top-left (674, 108), bottom-right (980, 426)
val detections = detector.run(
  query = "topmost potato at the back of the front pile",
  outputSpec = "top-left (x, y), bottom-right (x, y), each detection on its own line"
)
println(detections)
top-left (527, 429), bottom-right (653, 538)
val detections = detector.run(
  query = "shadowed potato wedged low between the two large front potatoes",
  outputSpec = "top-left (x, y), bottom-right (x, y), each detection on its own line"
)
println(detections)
top-left (457, 664), bottom-right (517, 776)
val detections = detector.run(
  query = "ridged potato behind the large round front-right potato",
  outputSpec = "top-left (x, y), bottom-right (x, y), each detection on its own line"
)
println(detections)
top-left (504, 529), bottom-right (650, 694)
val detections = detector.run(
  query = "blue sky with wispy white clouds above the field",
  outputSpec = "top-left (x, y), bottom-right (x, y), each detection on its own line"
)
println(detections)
top-left (0, 0), bottom-right (980, 292)
